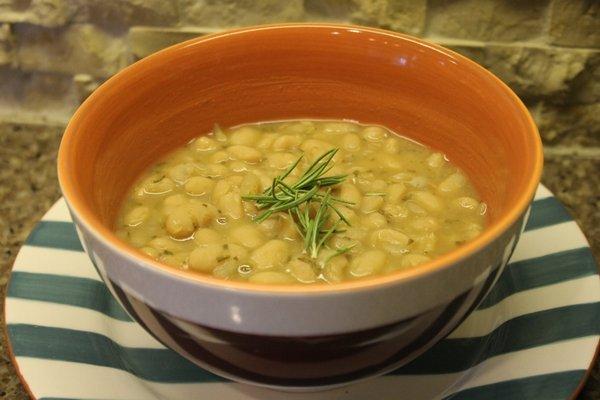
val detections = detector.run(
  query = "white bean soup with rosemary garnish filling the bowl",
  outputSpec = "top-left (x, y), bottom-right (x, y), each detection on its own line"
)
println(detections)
top-left (116, 121), bottom-right (486, 284)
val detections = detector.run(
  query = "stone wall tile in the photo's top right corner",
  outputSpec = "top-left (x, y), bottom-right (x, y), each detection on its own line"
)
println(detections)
top-left (549, 0), bottom-right (600, 48)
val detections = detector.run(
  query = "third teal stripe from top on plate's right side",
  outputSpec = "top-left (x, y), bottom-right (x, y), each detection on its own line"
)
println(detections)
top-left (394, 302), bottom-right (600, 375)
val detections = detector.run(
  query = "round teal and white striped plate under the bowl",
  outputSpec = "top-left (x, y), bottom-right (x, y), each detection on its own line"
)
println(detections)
top-left (6, 187), bottom-right (600, 400)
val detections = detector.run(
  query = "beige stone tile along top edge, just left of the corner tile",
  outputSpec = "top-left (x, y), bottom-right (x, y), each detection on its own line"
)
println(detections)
top-left (427, 0), bottom-right (549, 41)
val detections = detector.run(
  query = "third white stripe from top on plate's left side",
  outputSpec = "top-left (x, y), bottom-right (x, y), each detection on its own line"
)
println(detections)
top-left (6, 297), bottom-right (165, 349)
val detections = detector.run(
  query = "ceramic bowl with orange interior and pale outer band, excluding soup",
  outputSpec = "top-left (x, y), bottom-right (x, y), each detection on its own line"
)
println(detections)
top-left (58, 24), bottom-right (542, 390)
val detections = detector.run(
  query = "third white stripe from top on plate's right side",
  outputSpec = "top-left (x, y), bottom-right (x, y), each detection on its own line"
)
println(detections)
top-left (448, 275), bottom-right (600, 339)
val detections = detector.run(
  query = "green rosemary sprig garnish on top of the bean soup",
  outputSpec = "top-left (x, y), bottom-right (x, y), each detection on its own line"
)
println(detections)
top-left (242, 149), bottom-right (353, 262)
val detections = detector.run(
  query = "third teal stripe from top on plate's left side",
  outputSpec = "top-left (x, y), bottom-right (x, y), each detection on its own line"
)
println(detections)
top-left (8, 324), bottom-right (224, 383)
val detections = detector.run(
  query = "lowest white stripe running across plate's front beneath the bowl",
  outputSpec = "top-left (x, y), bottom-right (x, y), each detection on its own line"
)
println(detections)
top-left (17, 336), bottom-right (598, 400)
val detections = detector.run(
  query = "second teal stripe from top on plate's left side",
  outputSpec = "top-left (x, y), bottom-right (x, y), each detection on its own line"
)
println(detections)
top-left (8, 271), bottom-right (131, 321)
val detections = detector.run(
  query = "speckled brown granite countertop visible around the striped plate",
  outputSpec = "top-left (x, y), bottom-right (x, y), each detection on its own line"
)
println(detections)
top-left (0, 125), bottom-right (600, 400)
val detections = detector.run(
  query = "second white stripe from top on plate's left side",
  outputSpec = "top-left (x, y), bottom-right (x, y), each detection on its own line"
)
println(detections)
top-left (14, 246), bottom-right (100, 281)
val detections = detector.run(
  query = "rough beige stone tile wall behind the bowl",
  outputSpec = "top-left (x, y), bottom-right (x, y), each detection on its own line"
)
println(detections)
top-left (0, 0), bottom-right (600, 150)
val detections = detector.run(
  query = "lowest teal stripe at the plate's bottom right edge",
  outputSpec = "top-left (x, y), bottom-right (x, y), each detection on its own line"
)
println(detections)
top-left (444, 370), bottom-right (586, 400)
